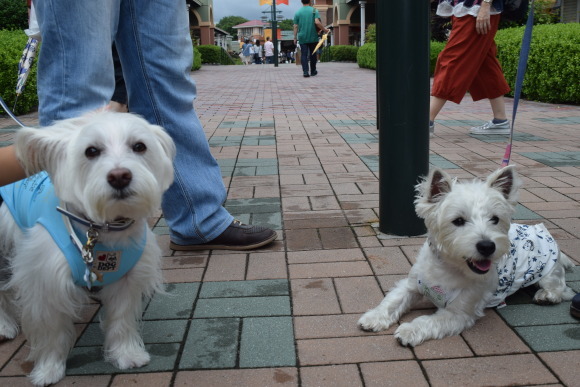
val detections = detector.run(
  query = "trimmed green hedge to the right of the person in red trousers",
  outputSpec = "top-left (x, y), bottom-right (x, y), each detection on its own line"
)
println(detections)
top-left (495, 23), bottom-right (580, 104)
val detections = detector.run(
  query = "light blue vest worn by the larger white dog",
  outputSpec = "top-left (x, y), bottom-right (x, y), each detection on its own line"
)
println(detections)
top-left (0, 172), bottom-right (147, 288)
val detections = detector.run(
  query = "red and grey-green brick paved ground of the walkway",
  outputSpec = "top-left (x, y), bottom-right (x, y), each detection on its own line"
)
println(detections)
top-left (0, 63), bottom-right (580, 386)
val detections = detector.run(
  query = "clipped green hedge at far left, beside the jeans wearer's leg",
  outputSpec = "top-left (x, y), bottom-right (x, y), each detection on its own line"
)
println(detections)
top-left (0, 30), bottom-right (38, 114)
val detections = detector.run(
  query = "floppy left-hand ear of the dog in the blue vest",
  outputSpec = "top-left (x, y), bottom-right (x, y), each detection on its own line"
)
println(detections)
top-left (14, 125), bottom-right (70, 175)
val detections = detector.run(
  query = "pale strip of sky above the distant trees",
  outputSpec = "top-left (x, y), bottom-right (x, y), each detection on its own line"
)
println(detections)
top-left (213, 0), bottom-right (302, 24)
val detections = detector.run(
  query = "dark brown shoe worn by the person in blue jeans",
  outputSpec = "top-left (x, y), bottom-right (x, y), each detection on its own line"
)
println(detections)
top-left (169, 220), bottom-right (278, 251)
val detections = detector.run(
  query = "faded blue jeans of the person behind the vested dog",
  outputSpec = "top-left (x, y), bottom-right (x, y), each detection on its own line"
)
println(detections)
top-left (34, 0), bottom-right (233, 244)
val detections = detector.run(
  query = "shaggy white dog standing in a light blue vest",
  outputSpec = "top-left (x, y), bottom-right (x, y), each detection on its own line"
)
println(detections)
top-left (0, 112), bottom-right (175, 385)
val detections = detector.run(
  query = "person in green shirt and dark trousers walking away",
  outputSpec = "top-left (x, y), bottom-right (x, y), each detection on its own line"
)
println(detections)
top-left (294, 0), bottom-right (328, 77)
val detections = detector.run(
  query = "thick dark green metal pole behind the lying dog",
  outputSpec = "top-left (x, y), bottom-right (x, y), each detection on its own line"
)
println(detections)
top-left (377, 0), bottom-right (429, 236)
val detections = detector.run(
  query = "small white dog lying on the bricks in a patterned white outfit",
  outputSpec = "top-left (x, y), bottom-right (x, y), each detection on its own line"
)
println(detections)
top-left (358, 166), bottom-right (574, 346)
